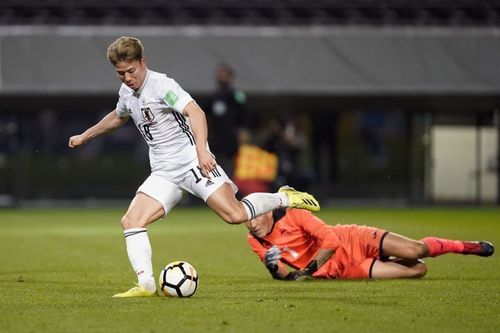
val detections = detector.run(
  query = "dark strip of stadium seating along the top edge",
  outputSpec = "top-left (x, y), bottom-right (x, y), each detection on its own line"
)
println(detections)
top-left (0, 0), bottom-right (500, 26)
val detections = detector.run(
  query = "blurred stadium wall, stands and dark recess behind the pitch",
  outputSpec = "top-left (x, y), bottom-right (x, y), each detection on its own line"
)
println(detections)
top-left (0, 0), bottom-right (500, 206)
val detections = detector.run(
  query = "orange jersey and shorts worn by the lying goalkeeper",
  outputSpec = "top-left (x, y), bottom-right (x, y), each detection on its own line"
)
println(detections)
top-left (247, 208), bottom-right (386, 279)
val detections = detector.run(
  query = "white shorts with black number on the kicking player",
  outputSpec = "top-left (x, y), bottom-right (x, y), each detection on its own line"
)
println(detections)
top-left (136, 160), bottom-right (238, 215)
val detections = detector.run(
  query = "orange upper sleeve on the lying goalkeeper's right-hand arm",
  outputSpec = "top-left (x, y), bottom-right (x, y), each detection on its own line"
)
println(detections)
top-left (293, 209), bottom-right (340, 250)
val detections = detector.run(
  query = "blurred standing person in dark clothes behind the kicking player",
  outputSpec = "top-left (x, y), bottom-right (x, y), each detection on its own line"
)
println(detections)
top-left (206, 63), bottom-right (249, 177)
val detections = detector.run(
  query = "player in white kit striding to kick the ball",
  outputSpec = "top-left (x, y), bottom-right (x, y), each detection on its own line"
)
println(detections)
top-left (68, 37), bottom-right (319, 297)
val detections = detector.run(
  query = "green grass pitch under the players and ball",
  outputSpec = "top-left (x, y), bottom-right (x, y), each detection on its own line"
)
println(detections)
top-left (0, 207), bottom-right (500, 333)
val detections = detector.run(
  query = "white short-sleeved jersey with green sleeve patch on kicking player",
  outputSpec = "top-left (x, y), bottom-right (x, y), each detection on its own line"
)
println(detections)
top-left (116, 70), bottom-right (197, 177)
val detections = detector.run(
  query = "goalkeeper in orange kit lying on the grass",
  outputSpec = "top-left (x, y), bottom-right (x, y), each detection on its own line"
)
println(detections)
top-left (246, 208), bottom-right (494, 280)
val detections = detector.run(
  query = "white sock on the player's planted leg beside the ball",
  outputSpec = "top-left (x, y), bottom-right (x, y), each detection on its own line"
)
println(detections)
top-left (123, 228), bottom-right (156, 292)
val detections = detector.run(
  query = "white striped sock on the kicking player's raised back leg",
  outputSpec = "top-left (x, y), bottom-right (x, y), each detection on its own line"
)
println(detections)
top-left (241, 193), bottom-right (288, 220)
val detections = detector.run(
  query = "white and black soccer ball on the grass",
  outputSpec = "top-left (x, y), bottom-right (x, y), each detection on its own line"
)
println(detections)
top-left (158, 261), bottom-right (198, 297)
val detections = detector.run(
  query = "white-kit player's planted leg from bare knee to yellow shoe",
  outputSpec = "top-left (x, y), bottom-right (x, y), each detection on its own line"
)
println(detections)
top-left (113, 192), bottom-right (165, 297)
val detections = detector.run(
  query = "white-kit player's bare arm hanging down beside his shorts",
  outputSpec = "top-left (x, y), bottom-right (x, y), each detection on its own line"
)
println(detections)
top-left (182, 101), bottom-right (217, 178)
